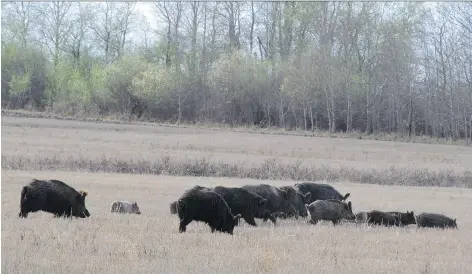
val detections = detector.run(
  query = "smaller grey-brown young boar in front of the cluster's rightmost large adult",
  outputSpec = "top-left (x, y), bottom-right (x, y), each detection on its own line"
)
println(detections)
top-left (305, 200), bottom-right (356, 226)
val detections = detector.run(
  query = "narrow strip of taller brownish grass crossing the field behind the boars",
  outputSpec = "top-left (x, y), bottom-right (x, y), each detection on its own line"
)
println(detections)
top-left (2, 155), bottom-right (472, 188)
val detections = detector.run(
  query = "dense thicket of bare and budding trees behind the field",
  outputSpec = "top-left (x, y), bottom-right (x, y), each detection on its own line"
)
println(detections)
top-left (1, 2), bottom-right (472, 140)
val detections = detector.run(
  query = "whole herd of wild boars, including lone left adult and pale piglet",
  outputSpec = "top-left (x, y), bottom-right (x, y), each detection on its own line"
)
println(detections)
top-left (18, 179), bottom-right (457, 235)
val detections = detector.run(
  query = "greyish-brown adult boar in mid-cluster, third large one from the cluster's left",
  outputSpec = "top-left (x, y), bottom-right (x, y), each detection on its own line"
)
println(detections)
top-left (243, 184), bottom-right (298, 218)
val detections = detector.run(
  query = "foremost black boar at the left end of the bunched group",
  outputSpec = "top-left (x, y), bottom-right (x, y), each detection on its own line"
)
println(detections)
top-left (177, 189), bottom-right (241, 235)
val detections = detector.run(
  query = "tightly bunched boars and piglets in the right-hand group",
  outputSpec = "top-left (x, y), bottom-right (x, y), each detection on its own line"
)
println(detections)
top-left (170, 182), bottom-right (457, 234)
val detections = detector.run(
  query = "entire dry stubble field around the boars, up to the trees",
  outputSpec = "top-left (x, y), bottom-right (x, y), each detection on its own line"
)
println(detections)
top-left (1, 117), bottom-right (472, 273)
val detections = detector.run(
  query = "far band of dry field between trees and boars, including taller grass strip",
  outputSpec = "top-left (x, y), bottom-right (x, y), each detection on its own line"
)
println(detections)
top-left (2, 116), bottom-right (472, 187)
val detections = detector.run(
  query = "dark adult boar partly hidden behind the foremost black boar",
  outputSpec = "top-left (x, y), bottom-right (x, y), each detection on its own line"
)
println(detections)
top-left (170, 185), bottom-right (276, 226)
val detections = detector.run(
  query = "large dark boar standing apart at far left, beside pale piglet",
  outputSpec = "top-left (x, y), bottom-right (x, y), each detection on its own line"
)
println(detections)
top-left (18, 179), bottom-right (90, 218)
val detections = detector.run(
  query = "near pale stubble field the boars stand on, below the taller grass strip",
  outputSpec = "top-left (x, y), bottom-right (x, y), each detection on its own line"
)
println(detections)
top-left (2, 170), bottom-right (472, 274)
